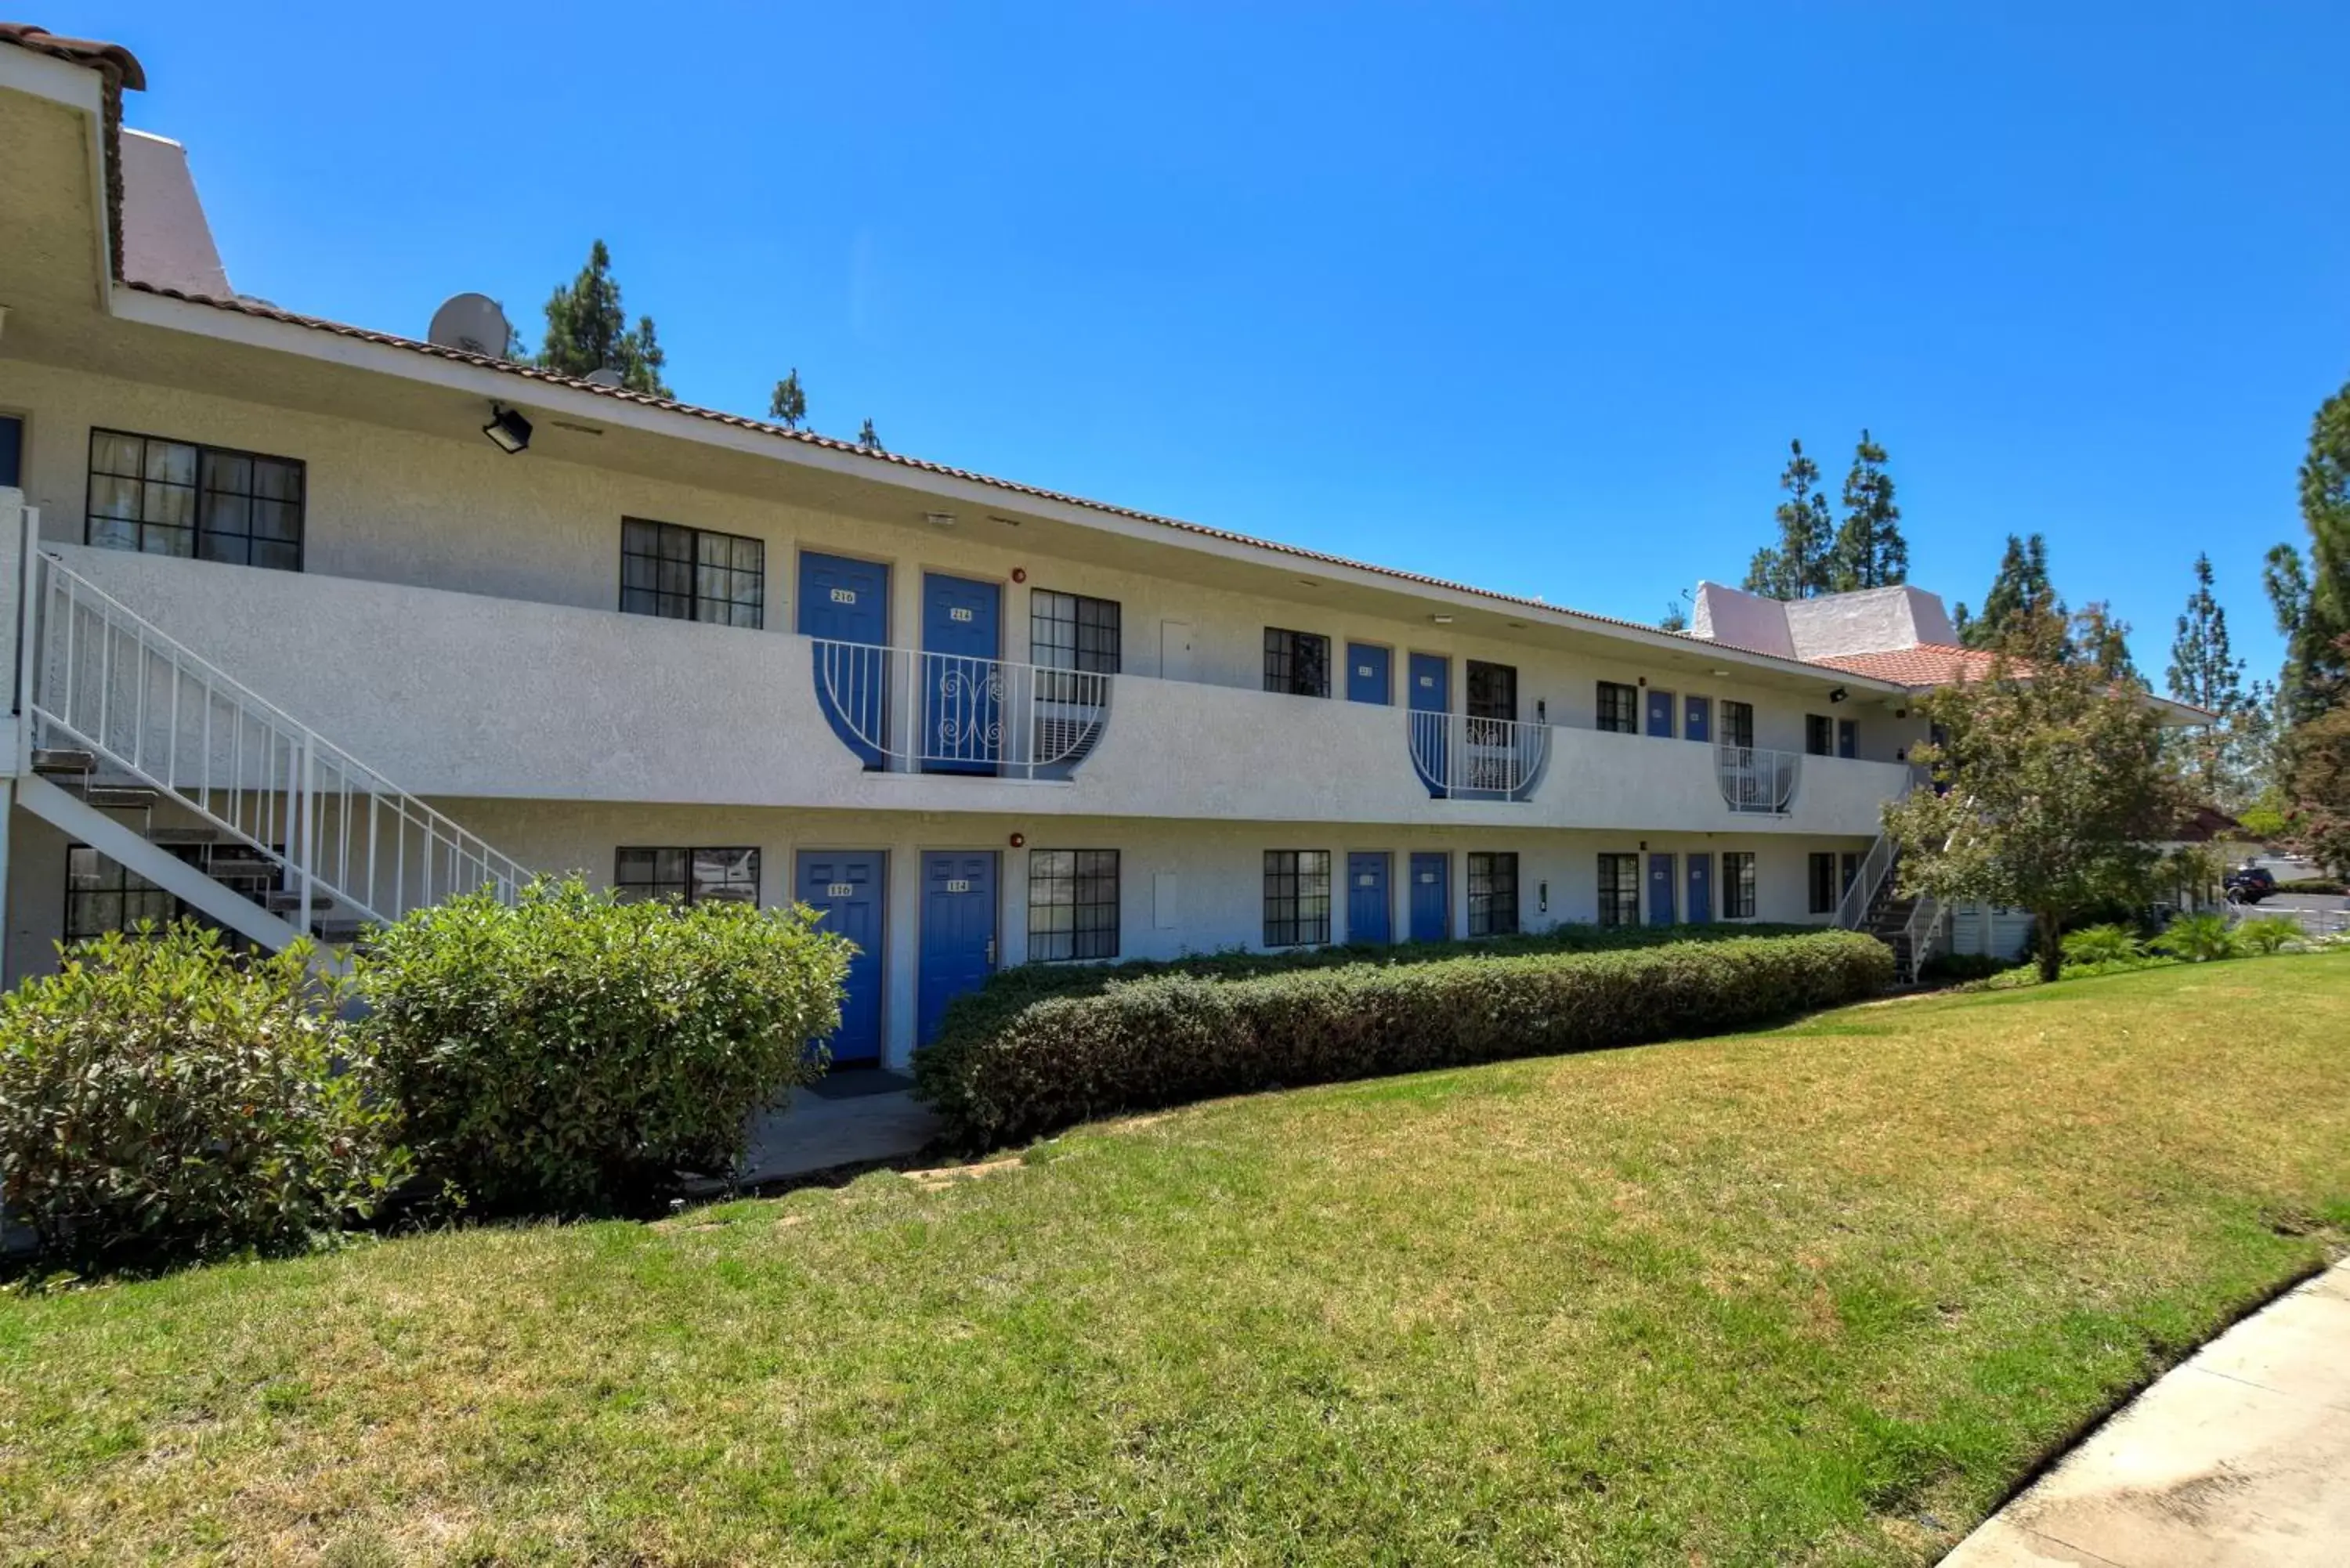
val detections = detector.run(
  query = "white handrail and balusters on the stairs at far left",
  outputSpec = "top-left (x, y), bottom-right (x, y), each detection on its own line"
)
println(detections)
top-left (16, 545), bottom-right (536, 924)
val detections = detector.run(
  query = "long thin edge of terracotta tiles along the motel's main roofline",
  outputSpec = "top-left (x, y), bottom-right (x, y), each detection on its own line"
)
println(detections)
top-left (125, 277), bottom-right (1908, 691)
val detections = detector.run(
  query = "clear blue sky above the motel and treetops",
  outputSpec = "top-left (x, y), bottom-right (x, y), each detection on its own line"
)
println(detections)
top-left (50, 0), bottom-right (2350, 681)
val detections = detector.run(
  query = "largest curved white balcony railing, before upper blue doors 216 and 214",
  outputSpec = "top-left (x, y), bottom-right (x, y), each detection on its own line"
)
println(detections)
top-left (811, 637), bottom-right (1112, 778)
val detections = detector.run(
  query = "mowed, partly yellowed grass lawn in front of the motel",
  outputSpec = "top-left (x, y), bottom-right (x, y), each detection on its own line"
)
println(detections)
top-left (13, 957), bottom-right (2350, 1563)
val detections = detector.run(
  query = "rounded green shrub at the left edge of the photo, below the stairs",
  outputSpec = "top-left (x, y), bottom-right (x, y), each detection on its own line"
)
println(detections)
top-left (0, 924), bottom-right (407, 1265)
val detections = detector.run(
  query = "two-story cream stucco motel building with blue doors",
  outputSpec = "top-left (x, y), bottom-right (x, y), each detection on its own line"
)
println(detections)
top-left (0, 31), bottom-right (1948, 1063)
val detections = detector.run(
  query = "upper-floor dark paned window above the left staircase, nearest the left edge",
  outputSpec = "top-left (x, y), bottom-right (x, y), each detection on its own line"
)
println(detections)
top-left (82, 430), bottom-right (303, 571)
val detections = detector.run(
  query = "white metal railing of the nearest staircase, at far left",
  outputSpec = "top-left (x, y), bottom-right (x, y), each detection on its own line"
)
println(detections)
top-left (19, 545), bottom-right (531, 931)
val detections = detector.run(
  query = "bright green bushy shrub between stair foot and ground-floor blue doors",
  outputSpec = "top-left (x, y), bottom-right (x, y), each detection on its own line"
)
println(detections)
top-left (357, 880), bottom-right (848, 1213)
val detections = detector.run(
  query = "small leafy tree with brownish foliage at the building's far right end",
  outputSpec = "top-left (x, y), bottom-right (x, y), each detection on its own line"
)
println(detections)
top-left (1885, 609), bottom-right (2186, 978)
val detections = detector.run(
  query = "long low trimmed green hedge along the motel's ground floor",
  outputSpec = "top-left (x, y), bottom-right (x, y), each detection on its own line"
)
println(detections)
top-left (914, 931), bottom-right (1892, 1143)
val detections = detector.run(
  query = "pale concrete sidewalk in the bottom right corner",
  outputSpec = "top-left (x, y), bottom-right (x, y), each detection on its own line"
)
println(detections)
top-left (1943, 1260), bottom-right (2350, 1568)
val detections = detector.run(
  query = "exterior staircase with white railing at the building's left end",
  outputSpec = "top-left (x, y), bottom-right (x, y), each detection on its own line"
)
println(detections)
top-left (16, 508), bottom-right (531, 962)
